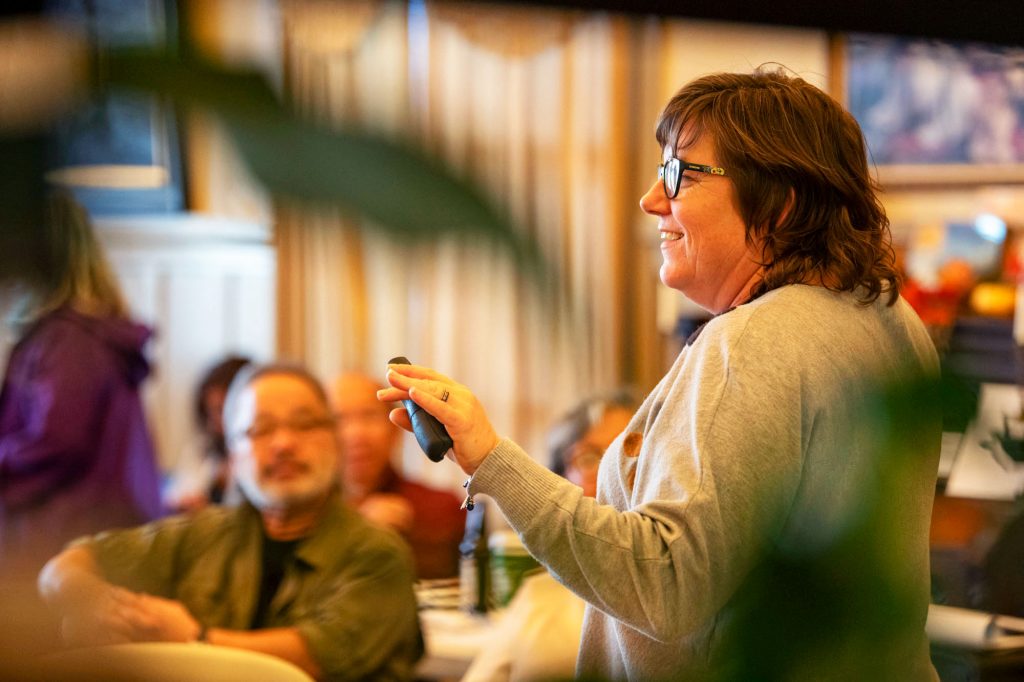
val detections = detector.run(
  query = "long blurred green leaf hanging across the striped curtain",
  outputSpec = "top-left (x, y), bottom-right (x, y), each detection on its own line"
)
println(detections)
top-left (99, 50), bottom-right (544, 272)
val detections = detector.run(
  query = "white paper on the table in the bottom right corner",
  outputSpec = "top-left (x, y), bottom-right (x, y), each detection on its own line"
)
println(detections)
top-left (926, 604), bottom-right (1024, 651)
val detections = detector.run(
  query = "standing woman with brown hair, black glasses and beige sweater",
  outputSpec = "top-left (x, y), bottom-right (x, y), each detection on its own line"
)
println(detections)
top-left (380, 70), bottom-right (941, 680)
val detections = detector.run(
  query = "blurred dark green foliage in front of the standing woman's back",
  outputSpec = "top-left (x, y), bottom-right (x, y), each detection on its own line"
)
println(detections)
top-left (714, 376), bottom-right (977, 682)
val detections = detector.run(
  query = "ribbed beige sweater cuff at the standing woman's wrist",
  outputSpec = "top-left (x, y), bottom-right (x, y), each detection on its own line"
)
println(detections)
top-left (469, 438), bottom-right (571, 531)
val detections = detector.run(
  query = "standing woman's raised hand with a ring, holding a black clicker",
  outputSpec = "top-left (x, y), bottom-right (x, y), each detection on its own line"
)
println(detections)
top-left (377, 365), bottom-right (500, 474)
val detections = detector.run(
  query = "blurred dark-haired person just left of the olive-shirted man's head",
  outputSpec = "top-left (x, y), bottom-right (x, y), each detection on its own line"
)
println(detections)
top-left (164, 355), bottom-right (251, 512)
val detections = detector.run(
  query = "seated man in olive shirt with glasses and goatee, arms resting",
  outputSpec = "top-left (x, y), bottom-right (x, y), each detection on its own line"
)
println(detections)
top-left (39, 366), bottom-right (423, 680)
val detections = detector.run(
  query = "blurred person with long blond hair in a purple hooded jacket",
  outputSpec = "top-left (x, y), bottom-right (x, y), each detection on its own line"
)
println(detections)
top-left (0, 188), bottom-right (161, 585)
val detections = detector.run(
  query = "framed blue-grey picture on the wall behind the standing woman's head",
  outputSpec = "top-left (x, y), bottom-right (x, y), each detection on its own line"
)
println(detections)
top-left (834, 34), bottom-right (1024, 186)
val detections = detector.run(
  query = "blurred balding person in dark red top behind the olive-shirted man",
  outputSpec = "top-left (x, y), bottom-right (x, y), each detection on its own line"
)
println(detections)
top-left (331, 374), bottom-right (466, 579)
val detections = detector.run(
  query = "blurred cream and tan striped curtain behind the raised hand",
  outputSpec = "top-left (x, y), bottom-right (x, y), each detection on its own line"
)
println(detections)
top-left (278, 2), bottom-right (632, 485)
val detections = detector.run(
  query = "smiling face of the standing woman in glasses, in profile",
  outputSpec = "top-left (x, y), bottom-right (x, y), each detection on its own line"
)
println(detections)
top-left (640, 131), bottom-right (761, 313)
